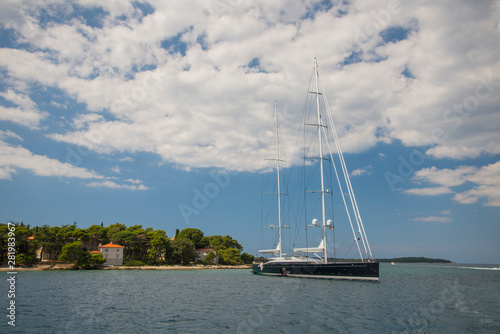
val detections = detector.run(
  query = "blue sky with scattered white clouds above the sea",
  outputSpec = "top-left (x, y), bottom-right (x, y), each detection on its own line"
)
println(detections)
top-left (0, 0), bottom-right (500, 264)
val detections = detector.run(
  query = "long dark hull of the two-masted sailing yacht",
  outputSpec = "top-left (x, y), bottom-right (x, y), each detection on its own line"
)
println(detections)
top-left (252, 262), bottom-right (379, 281)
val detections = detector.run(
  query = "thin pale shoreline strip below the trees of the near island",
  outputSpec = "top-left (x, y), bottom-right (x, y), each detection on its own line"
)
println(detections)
top-left (0, 264), bottom-right (252, 272)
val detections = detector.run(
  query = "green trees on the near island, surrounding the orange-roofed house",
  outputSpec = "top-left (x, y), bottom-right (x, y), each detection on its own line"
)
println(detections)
top-left (0, 222), bottom-right (254, 268)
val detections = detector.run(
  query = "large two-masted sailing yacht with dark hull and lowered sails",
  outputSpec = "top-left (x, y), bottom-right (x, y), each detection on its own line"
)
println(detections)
top-left (252, 58), bottom-right (379, 281)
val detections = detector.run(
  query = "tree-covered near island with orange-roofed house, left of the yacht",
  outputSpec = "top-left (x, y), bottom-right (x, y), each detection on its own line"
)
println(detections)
top-left (0, 222), bottom-right (254, 270)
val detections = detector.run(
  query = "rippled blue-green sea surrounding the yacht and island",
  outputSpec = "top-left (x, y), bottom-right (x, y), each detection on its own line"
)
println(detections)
top-left (0, 263), bottom-right (500, 334)
